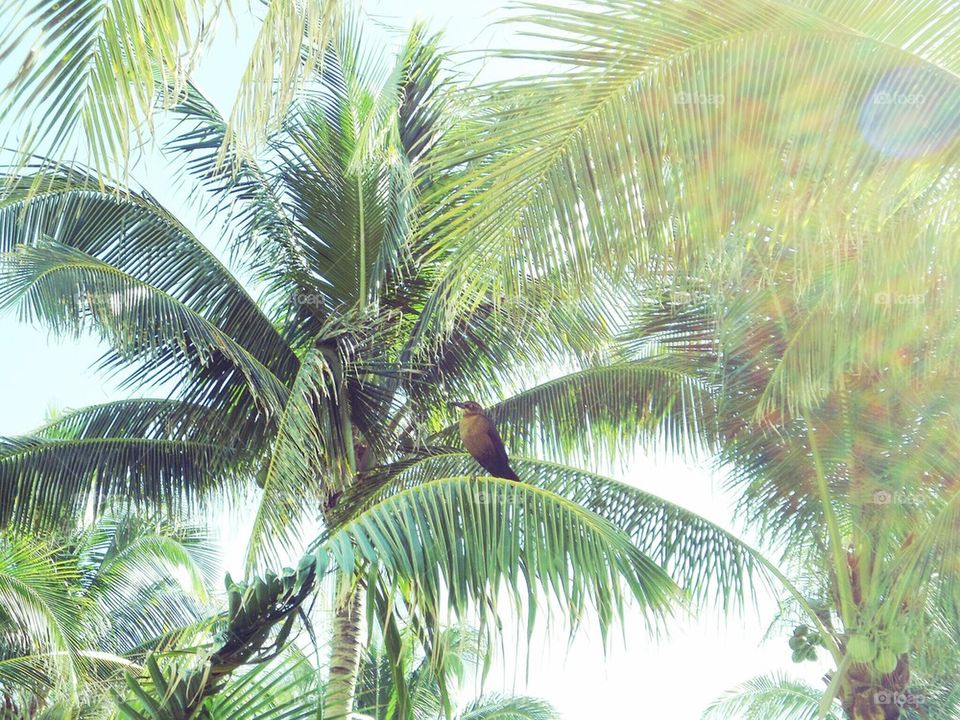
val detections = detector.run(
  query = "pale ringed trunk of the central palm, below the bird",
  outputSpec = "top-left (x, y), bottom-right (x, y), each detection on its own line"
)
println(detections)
top-left (323, 577), bottom-right (363, 720)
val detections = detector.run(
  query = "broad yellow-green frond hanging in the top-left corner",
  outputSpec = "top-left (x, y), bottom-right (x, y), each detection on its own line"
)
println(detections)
top-left (0, 0), bottom-right (208, 175)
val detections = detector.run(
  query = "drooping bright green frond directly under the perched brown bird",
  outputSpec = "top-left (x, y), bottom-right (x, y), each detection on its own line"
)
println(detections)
top-left (322, 478), bottom-right (675, 633)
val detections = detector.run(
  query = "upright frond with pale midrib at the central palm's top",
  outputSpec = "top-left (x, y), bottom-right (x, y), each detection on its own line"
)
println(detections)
top-left (268, 43), bottom-right (413, 312)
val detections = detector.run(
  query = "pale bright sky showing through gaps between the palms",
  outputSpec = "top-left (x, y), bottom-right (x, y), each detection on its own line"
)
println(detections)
top-left (0, 0), bottom-right (827, 720)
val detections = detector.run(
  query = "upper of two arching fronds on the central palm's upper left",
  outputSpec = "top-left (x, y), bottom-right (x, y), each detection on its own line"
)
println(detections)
top-left (0, 168), bottom-right (297, 410)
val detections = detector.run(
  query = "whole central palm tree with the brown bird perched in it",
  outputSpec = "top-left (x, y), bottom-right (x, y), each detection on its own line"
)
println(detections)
top-left (0, 15), bottom-right (763, 718)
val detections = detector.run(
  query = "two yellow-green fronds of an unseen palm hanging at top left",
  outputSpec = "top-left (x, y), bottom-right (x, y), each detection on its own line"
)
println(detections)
top-left (0, 0), bottom-right (343, 178)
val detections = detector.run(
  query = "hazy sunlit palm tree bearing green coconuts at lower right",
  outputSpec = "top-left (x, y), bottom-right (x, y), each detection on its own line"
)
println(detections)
top-left (633, 276), bottom-right (960, 720)
